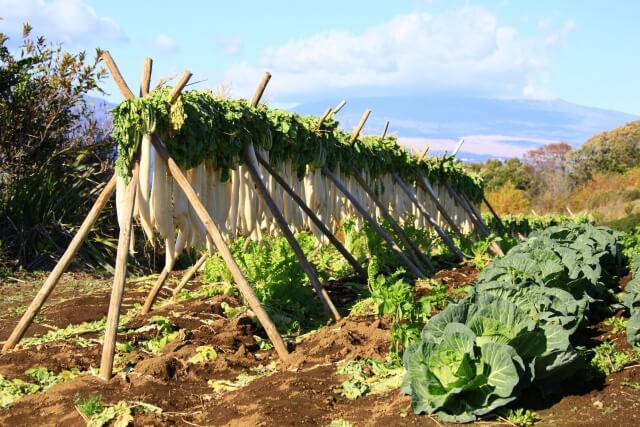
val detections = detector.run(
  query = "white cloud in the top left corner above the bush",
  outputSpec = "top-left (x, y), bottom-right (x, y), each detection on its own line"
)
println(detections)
top-left (0, 0), bottom-right (128, 44)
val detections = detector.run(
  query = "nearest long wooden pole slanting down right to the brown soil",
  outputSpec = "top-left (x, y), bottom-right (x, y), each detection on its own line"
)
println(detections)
top-left (151, 134), bottom-right (289, 360)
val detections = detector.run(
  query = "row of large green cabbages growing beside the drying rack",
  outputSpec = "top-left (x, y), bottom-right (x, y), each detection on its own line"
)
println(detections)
top-left (402, 224), bottom-right (628, 422)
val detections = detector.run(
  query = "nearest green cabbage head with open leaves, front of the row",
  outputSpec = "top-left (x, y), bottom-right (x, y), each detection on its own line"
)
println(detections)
top-left (402, 322), bottom-right (525, 422)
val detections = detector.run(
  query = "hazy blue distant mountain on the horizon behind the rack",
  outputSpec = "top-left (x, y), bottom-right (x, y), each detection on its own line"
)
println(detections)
top-left (293, 95), bottom-right (638, 161)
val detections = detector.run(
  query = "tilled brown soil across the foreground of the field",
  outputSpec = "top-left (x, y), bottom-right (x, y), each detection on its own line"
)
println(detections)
top-left (0, 269), bottom-right (640, 427)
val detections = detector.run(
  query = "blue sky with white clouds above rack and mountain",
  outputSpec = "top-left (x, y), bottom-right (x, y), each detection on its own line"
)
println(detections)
top-left (0, 0), bottom-right (640, 114)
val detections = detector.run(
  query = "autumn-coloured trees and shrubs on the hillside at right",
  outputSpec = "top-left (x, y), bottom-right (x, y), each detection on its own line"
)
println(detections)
top-left (468, 121), bottom-right (640, 229)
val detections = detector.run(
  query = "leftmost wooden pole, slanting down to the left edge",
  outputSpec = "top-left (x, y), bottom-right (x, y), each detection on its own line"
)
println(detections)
top-left (2, 175), bottom-right (116, 352)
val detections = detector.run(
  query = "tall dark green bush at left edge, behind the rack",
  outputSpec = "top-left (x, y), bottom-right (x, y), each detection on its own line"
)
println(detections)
top-left (0, 25), bottom-right (117, 270)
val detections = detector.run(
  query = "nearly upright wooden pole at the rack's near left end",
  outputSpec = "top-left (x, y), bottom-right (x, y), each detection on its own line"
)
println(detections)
top-left (100, 167), bottom-right (140, 381)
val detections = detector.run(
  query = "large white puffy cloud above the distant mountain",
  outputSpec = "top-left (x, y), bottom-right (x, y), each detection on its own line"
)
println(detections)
top-left (225, 5), bottom-right (575, 99)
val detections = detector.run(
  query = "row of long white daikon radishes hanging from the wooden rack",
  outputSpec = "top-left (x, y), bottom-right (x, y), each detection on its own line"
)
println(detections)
top-left (117, 136), bottom-right (478, 268)
